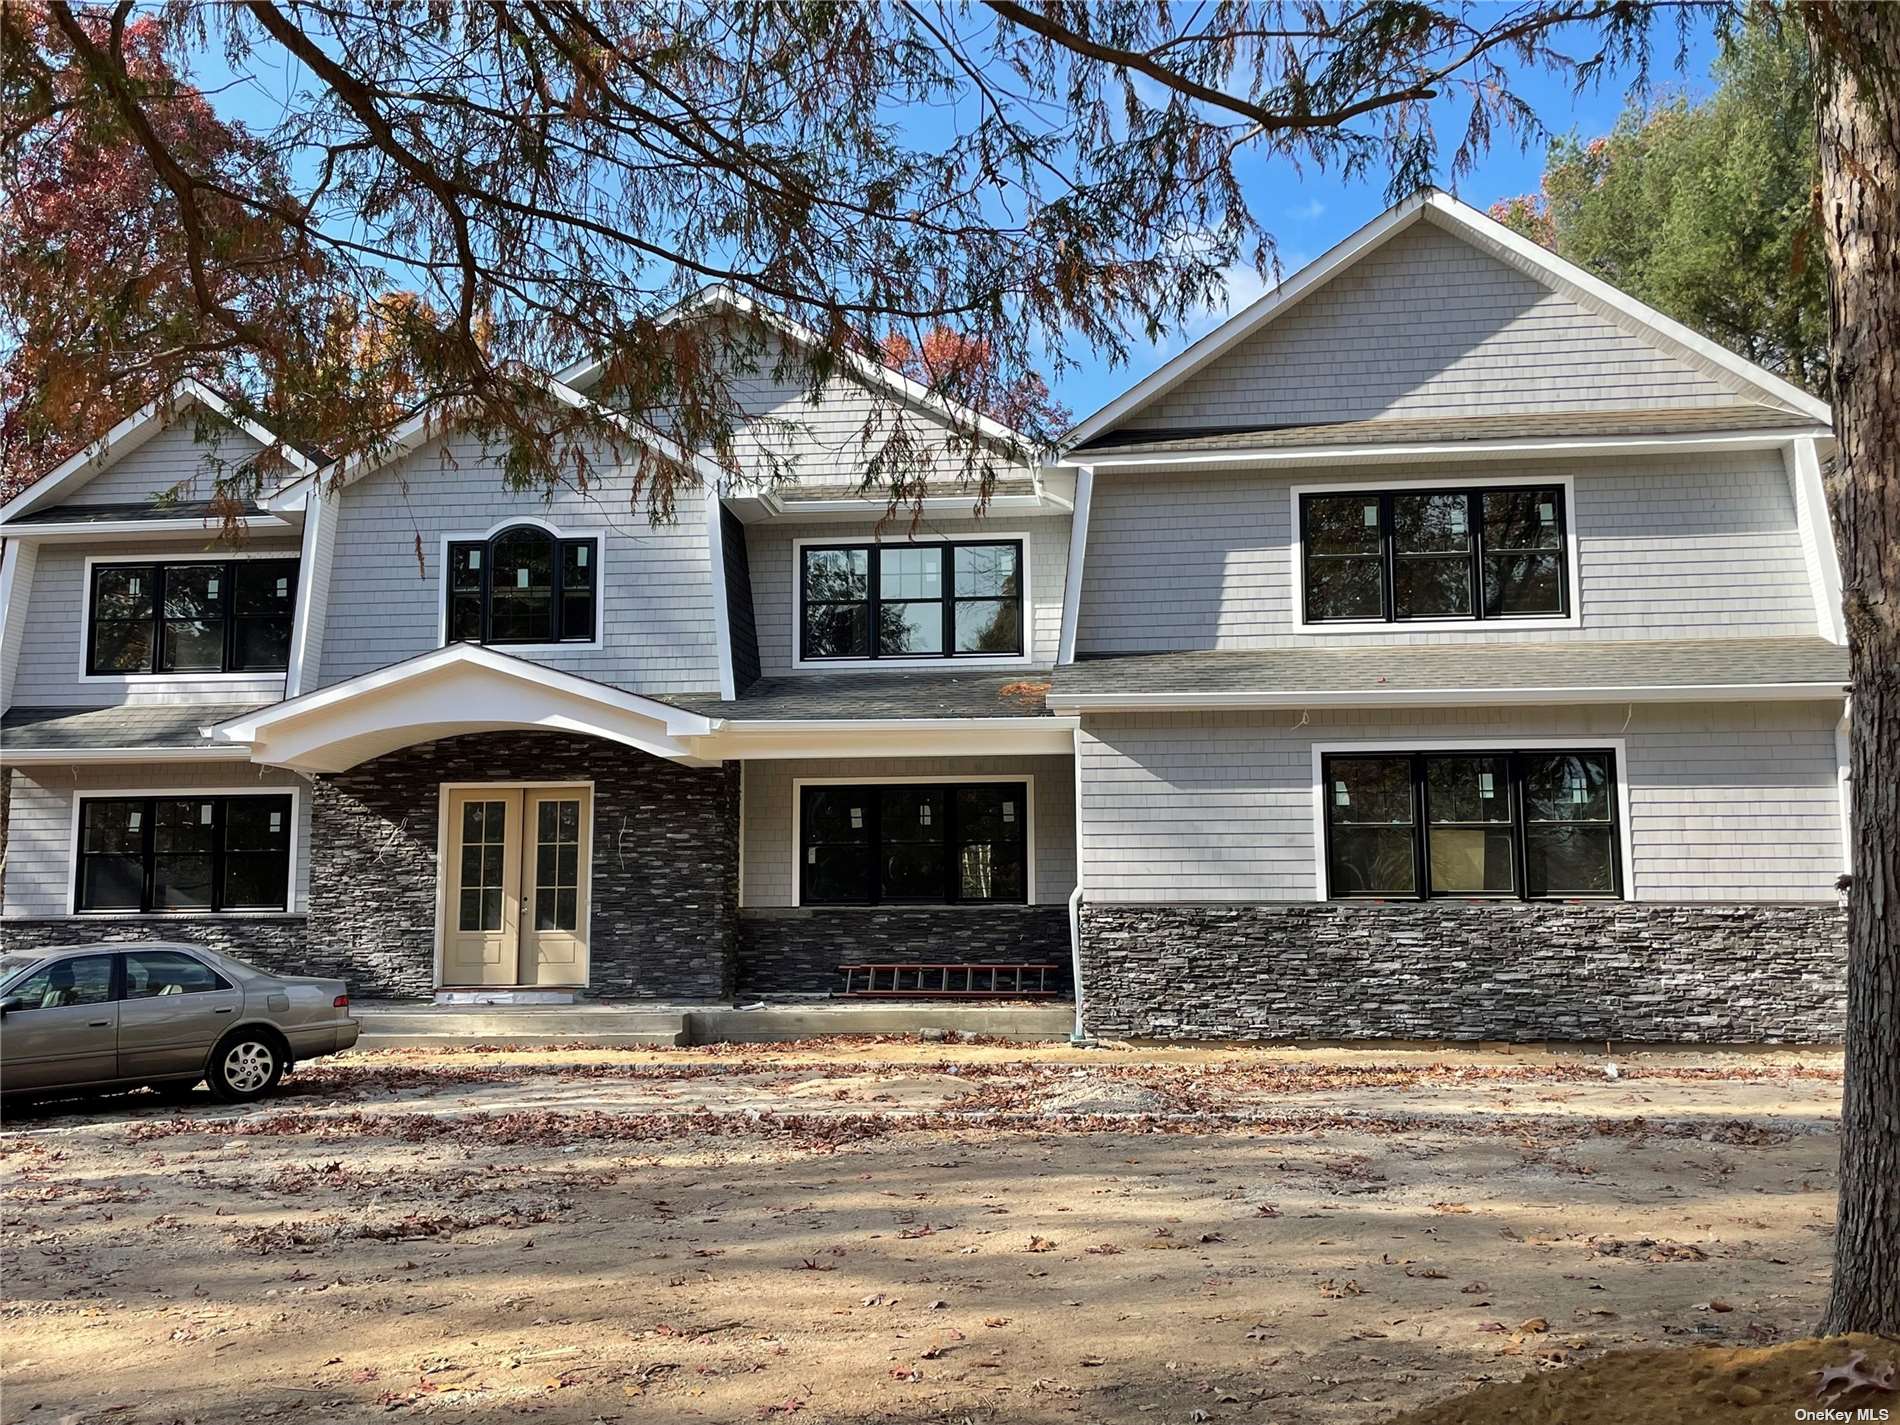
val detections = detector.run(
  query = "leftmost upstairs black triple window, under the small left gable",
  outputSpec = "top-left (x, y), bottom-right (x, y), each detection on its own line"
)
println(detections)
top-left (86, 559), bottom-right (296, 676)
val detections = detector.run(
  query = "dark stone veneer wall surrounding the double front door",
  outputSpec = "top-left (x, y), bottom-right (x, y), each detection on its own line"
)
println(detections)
top-left (310, 732), bottom-right (739, 999)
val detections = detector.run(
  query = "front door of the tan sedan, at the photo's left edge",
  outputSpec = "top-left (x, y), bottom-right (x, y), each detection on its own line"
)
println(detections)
top-left (0, 956), bottom-right (118, 1093)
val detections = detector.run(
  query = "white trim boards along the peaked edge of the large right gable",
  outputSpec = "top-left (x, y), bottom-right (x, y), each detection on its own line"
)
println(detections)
top-left (1062, 188), bottom-right (1834, 450)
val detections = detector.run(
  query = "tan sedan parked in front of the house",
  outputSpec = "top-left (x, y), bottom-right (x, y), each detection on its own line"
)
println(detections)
top-left (0, 942), bottom-right (359, 1104)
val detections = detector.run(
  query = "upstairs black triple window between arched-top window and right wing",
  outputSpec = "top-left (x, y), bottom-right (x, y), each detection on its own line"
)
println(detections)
top-left (798, 540), bottom-right (1022, 661)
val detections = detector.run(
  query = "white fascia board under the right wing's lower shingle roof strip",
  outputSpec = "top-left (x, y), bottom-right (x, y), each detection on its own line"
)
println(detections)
top-left (1049, 682), bottom-right (1847, 713)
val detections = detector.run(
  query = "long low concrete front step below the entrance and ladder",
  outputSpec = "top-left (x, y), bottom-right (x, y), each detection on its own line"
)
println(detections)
top-left (352, 999), bottom-right (1074, 1049)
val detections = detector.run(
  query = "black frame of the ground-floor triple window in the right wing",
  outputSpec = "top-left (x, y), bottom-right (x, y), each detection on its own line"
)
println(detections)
top-left (1319, 745), bottom-right (1628, 901)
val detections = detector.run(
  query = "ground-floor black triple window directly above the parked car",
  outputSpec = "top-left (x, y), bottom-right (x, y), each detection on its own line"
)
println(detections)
top-left (72, 794), bottom-right (293, 912)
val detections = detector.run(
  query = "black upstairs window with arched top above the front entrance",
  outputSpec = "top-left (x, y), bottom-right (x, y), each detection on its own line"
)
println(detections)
top-left (447, 524), bottom-right (600, 644)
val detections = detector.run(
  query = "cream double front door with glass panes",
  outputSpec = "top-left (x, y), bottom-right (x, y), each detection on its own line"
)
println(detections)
top-left (443, 787), bottom-right (593, 988)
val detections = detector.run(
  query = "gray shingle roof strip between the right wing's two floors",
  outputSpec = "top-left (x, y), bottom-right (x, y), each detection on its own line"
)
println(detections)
top-left (1051, 638), bottom-right (1847, 707)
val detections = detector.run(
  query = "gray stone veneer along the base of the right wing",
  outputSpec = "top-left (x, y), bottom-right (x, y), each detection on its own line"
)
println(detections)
top-left (1081, 901), bottom-right (1847, 1043)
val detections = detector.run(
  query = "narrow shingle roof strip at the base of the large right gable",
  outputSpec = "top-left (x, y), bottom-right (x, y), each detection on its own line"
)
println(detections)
top-left (1070, 403), bottom-right (1826, 456)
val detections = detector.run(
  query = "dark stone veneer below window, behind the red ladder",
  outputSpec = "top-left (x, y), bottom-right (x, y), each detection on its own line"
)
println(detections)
top-left (739, 906), bottom-right (1070, 996)
